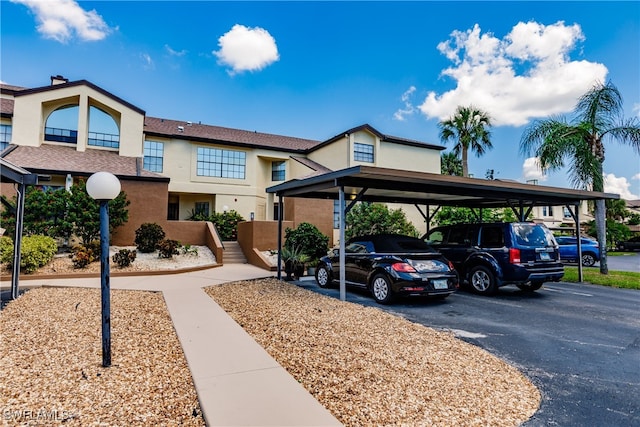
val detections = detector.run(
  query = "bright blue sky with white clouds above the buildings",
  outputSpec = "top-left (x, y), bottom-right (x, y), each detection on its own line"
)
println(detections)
top-left (0, 0), bottom-right (640, 199)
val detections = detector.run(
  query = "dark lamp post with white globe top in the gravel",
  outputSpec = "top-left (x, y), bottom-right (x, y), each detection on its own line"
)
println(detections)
top-left (87, 172), bottom-right (120, 368)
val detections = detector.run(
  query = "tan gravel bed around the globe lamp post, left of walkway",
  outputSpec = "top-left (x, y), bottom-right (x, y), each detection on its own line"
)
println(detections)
top-left (0, 288), bottom-right (204, 426)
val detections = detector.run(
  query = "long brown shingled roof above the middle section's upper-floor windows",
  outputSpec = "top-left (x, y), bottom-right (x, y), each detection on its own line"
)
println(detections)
top-left (144, 117), bottom-right (320, 153)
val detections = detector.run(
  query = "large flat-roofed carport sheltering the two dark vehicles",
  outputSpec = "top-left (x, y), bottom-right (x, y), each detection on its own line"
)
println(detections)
top-left (266, 166), bottom-right (620, 301)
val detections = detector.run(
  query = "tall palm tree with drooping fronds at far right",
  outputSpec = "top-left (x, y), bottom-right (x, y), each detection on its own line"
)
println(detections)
top-left (520, 82), bottom-right (640, 274)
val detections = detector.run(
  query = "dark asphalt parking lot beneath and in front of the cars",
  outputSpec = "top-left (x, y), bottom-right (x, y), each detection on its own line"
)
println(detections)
top-left (297, 266), bottom-right (640, 427)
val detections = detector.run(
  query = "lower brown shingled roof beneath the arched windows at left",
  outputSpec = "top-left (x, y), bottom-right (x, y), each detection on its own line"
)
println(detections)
top-left (2, 144), bottom-right (169, 182)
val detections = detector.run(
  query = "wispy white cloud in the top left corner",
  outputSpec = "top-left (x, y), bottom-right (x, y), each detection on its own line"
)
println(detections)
top-left (11, 0), bottom-right (112, 43)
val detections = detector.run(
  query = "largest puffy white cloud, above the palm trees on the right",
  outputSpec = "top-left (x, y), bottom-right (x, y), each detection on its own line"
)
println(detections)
top-left (419, 21), bottom-right (607, 126)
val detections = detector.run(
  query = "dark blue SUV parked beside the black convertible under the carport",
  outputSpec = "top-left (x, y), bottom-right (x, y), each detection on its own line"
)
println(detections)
top-left (423, 222), bottom-right (564, 295)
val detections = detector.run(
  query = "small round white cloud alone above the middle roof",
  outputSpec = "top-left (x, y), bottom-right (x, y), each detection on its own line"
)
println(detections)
top-left (213, 24), bottom-right (280, 74)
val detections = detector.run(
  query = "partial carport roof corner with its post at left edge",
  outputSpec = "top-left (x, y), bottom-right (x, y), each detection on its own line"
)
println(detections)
top-left (0, 158), bottom-right (38, 299)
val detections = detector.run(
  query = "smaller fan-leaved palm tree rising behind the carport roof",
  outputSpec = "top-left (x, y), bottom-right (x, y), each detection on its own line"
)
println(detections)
top-left (438, 106), bottom-right (493, 176)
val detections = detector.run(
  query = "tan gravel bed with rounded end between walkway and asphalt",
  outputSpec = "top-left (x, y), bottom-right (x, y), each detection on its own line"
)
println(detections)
top-left (206, 279), bottom-right (540, 426)
